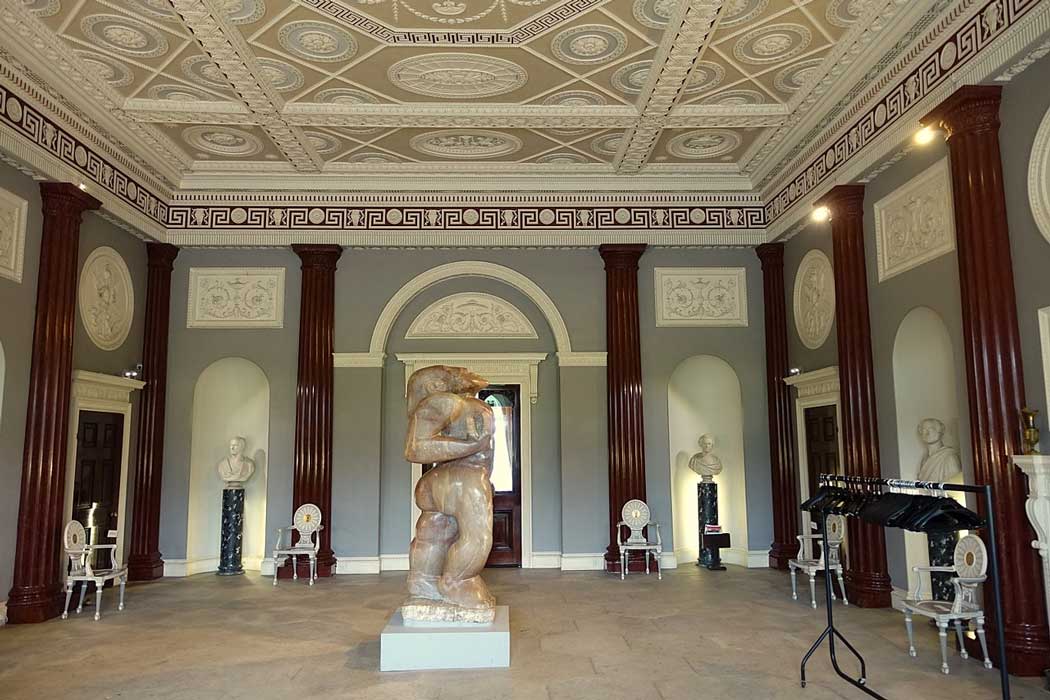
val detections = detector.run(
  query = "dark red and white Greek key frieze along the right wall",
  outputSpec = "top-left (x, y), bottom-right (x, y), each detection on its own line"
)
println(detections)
top-left (765, 0), bottom-right (1041, 222)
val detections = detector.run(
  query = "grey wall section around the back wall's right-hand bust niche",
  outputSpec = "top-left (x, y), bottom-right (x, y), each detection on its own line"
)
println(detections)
top-left (638, 249), bottom-right (773, 551)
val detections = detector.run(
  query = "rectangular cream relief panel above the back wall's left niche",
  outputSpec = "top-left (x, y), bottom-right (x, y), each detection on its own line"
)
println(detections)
top-left (186, 268), bottom-right (285, 328)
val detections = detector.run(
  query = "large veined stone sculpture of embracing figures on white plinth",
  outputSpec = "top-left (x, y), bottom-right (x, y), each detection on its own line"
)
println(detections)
top-left (401, 365), bottom-right (496, 623)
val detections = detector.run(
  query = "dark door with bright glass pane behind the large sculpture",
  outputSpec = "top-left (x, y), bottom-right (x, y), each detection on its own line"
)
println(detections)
top-left (478, 385), bottom-right (522, 567)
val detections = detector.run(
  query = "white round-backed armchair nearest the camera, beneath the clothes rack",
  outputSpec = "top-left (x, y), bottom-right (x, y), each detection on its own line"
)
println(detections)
top-left (903, 534), bottom-right (991, 674)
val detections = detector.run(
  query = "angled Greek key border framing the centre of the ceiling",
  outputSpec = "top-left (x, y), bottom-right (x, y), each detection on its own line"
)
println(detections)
top-left (299, 0), bottom-right (609, 46)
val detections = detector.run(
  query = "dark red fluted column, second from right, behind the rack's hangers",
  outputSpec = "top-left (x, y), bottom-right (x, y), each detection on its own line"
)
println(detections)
top-left (820, 185), bottom-right (893, 608)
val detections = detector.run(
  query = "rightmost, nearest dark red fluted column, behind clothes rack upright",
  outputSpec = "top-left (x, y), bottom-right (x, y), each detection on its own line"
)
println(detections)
top-left (923, 85), bottom-right (1050, 676)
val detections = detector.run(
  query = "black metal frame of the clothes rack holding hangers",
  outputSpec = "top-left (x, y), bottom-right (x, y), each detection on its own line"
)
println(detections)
top-left (799, 474), bottom-right (1010, 700)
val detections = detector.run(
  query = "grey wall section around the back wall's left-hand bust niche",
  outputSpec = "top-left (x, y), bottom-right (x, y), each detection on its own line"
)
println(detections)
top-left (161, 249), bottom-right (301, 559)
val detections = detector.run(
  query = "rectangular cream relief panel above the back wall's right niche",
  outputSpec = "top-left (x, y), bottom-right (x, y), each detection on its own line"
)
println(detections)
top-left (655, 268), bottom-right (748, 326)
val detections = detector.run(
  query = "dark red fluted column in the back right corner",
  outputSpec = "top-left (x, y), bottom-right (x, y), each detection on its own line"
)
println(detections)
top-left (755, 243), bottom-right (799, 569)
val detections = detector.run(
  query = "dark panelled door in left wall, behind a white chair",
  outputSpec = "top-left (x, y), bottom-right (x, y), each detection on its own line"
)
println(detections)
top-left (70, 410), bottom-right (124, 567)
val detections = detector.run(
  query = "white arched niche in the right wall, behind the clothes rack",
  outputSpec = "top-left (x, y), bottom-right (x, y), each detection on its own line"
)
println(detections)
top-left (894, 306), bottom-right (962, 593)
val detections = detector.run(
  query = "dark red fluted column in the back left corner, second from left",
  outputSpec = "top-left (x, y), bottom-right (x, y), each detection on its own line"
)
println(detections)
top-left (128, 243), bottom-right (179, 581)
